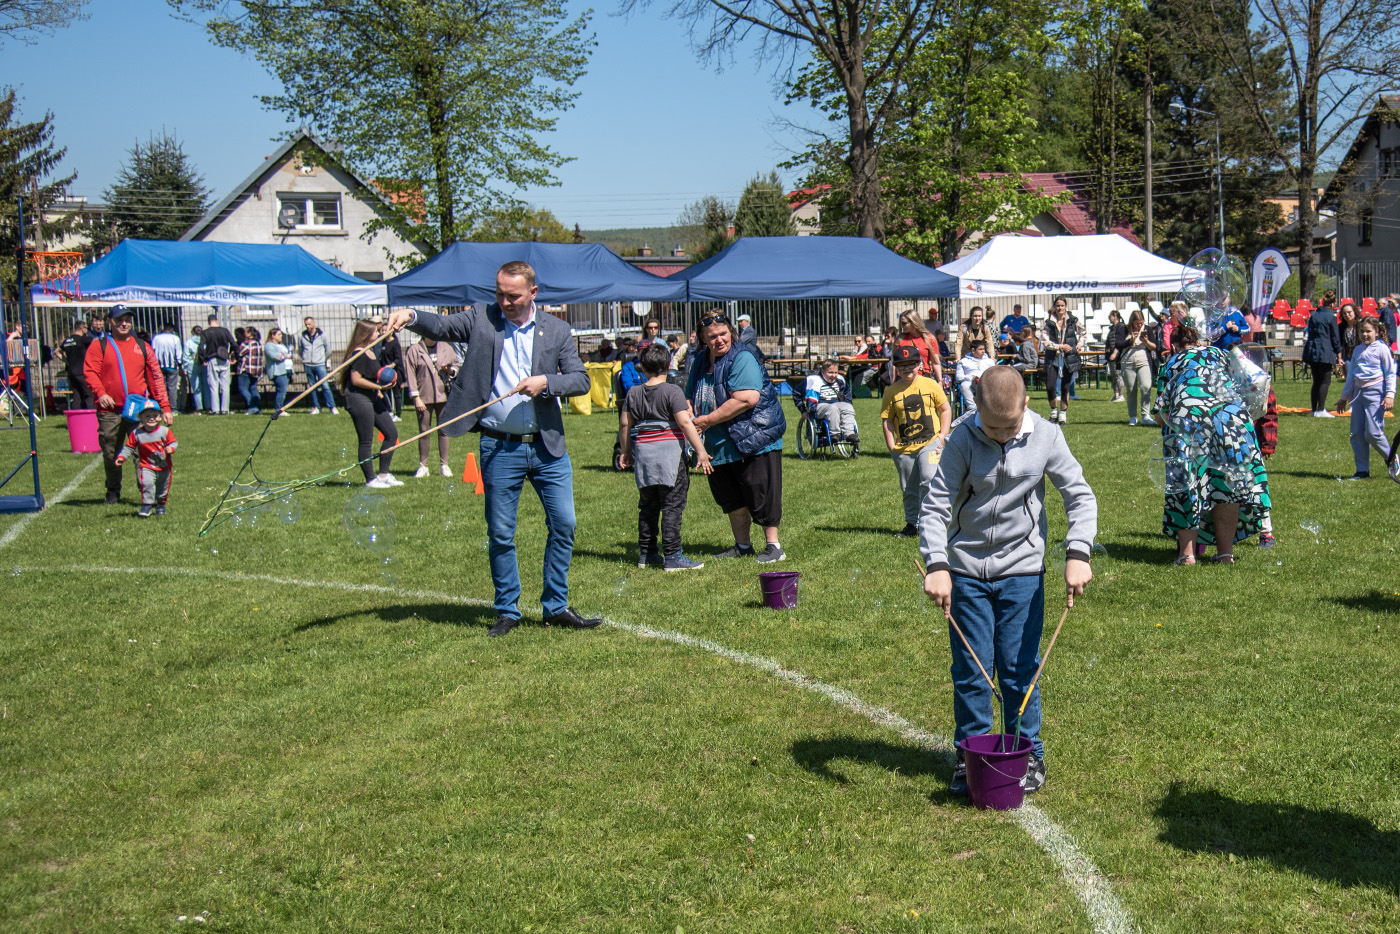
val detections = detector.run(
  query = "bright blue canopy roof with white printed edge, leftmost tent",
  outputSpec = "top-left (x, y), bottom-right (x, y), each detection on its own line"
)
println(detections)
top-left (32, 239), bottom-right (385, 305)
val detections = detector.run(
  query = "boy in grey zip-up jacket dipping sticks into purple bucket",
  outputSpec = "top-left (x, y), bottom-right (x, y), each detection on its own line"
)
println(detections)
top-left (918, 367), bottom-right (1099, 795)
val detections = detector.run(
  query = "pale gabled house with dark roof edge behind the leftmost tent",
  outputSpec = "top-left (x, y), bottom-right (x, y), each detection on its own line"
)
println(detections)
top-left (181, 129), bottom-right (424, 281)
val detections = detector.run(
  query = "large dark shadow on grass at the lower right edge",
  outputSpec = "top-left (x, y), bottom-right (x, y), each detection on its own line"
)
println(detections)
top-left (1156, 781), bottom-right (1400, 893)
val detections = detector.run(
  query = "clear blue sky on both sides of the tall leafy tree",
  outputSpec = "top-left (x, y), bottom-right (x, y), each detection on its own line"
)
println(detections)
top-left (0, 0), bottom-right (820, 230)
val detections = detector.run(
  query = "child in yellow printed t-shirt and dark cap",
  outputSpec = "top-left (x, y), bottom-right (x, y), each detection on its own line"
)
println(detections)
top-left (879, 344), bottom-right (953, 538)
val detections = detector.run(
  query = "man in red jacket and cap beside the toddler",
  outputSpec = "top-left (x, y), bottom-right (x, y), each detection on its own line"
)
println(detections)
top-left (83, 305), bottom-right (174, 506)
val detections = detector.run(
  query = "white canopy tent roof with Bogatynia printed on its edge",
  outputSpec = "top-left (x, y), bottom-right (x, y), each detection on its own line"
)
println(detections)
top-left (938, 234), bottom-right (1186, 298)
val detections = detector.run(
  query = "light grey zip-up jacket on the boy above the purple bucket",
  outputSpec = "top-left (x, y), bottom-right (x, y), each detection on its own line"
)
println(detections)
top-left (918, 410), bottom-right (1099, 581)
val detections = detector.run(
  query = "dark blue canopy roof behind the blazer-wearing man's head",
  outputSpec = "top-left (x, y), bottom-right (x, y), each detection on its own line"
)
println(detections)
top-left (385, 242), bottom-right (688, 307)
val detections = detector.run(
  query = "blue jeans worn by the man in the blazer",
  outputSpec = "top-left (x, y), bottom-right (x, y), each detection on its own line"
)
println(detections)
top-left (482, 434), bottom-right (578, 616)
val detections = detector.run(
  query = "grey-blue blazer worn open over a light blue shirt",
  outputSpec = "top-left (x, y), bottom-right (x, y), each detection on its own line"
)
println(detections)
top-left (409, 304), bottom-right (589, 458)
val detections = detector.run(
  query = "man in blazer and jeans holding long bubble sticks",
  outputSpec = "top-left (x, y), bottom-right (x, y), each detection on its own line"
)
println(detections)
top-left (388, 260), bottom-right (602, 636)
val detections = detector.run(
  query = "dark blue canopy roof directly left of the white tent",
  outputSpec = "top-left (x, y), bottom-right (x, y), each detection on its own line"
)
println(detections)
top-left (671, 237), bottom-right (958, 301)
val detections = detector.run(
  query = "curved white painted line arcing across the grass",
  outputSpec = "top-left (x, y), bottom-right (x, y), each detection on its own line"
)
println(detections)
top-left (15, 564), bottom-right (1138, 934)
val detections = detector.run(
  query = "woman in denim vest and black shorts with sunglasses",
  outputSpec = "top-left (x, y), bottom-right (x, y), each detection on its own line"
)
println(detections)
top-left (686, 308), bottom-right (787, 564)
